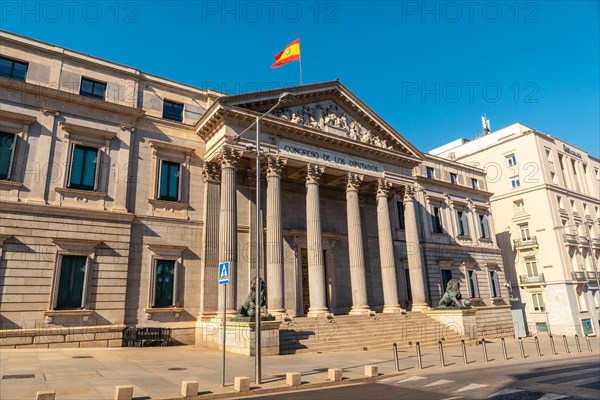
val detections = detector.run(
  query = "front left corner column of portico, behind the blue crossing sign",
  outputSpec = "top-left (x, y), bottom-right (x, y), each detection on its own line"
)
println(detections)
top-left (219, 147), bottom-right (241, 314)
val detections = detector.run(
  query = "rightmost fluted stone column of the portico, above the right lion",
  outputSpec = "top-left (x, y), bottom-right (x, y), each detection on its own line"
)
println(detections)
top-left (404, 186), bottom-right (429, 311)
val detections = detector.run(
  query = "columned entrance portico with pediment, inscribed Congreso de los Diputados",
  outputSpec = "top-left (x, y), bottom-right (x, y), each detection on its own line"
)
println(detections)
top-left (198, 82), bottom-right (427, 317)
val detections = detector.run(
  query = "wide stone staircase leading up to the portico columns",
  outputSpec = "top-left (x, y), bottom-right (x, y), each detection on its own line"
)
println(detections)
top-left (279, 312), bottom-right (462, 354)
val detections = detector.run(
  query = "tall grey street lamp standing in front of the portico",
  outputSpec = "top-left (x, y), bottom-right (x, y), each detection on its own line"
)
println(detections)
top-left (232, 92), bottom-right (295, 384)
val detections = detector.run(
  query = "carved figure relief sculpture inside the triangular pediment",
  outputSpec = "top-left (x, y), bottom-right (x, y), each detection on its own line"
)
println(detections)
top-left (273, 100), bottom-right (392, 149)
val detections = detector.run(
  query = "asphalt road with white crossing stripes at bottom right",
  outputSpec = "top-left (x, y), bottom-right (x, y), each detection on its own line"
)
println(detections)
top-left (246, 354), bottom-right (600, 400)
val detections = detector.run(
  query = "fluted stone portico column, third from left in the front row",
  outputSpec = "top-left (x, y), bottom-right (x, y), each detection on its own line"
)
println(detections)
top-left (306, 164), bottom-right (328, 317)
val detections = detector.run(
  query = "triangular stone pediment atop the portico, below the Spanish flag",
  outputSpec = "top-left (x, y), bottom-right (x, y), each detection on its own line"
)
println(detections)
top-left (219, 81), bottom-right (423, 159)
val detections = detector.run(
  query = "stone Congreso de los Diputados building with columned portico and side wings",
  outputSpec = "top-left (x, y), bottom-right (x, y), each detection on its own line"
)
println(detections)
top-left (0, 32), bottom-right (512, 347)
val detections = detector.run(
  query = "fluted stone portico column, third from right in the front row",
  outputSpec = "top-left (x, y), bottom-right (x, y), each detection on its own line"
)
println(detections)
top-left (346, 172), bottom-right (369, 315)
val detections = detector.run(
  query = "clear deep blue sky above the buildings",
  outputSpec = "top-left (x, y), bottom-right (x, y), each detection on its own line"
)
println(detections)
top-left (0, 0), bottom-right (600, 157)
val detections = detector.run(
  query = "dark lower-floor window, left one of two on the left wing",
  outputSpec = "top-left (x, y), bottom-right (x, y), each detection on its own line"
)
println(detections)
top-left (55, 255), bottom-right (88, 310)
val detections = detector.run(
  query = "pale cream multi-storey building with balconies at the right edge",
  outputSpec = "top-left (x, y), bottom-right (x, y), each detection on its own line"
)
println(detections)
top-left (431, 123), bottom-right (600, 335)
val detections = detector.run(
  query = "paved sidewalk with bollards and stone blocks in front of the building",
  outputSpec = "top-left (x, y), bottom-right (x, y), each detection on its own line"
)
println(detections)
top-left (0, 337), bottom-right (600, 400)
